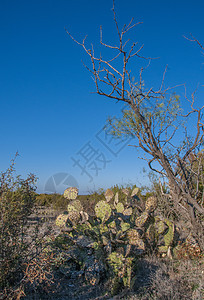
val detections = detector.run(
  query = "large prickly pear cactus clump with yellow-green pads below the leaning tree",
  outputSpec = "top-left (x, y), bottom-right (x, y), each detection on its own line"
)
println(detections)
top-left (53, 188), bottom-right (186, 293)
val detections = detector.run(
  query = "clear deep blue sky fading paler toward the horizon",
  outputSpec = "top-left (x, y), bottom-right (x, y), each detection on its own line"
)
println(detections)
top-left (0, 0), bottom-right (204, 193)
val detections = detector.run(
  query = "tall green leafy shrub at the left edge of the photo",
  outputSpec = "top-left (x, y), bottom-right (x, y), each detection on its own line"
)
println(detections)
top-left (0, 155), bottom-right (36, 289)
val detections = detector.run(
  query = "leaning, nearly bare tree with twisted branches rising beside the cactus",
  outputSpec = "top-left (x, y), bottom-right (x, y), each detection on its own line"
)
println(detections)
top-left (67, 1), bottom-right (204, 244)
